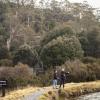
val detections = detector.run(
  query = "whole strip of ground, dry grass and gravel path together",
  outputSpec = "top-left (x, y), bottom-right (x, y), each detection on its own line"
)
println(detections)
top-left (0, 81), bottom-right (100, 100)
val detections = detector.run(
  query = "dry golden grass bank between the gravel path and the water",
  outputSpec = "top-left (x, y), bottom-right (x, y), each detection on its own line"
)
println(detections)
top-left (40, 81), bottom-right (100, 100)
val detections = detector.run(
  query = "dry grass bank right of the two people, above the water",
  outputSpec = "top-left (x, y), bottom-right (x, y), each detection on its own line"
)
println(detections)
top-left (64, 81), bottom-right (100, 97)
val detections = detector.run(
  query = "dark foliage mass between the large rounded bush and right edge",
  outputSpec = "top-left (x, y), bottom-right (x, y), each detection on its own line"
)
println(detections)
top-left (79, 29), bottom-right (100, 58)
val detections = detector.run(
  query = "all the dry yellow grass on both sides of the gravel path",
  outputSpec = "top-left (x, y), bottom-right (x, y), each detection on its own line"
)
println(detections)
top-left (0, 81), bottom-right (100, 100)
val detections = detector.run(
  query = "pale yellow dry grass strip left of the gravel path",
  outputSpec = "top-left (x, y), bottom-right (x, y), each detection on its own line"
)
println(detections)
top-left (0, 87), bottom-right (38, 100)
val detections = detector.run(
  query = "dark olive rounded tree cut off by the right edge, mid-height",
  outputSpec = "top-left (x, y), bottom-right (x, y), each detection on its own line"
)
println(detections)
top-left (87, 30), bottom-right (100, 57)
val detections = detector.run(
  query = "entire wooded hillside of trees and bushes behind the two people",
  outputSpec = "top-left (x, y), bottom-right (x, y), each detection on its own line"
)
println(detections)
top-left (0, 0), bottom-right (100, 87)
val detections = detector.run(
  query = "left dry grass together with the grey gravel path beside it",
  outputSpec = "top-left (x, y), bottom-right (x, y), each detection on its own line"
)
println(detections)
top-left (0, 87), bottom-right (52, 100)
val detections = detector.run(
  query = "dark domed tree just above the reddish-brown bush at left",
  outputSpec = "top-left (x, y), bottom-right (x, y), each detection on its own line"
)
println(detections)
top-left (13, 47), bottom-right (36, 66)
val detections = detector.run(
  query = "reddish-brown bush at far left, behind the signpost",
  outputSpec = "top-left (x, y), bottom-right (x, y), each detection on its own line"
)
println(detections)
top-left (0, 63), bottom-right (32, 88)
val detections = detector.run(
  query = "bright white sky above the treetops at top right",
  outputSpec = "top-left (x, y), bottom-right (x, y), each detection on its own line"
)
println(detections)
top-left (69, 0), bottom-right (100, 8)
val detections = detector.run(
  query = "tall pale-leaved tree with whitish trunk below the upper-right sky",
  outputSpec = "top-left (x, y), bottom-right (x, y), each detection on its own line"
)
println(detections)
top-left (69, 2), bottom-right (98, 33)
